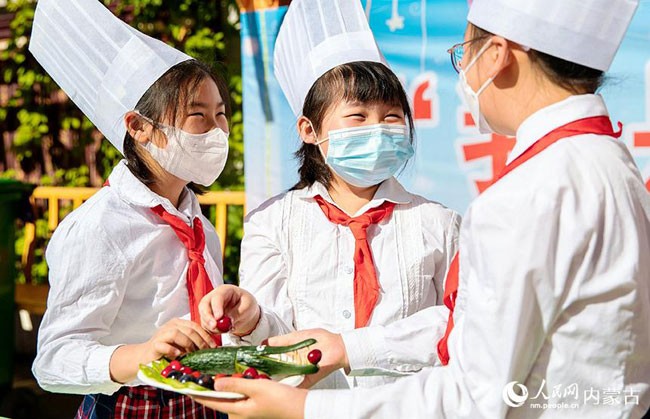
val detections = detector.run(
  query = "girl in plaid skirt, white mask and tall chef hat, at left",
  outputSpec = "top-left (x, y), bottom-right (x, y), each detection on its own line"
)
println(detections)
top-left (30, 0), bottom-right (230, 418)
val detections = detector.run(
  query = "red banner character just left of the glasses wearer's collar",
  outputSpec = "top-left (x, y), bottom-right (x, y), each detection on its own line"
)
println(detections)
top-left (461, 112), bottom-right (515, 193)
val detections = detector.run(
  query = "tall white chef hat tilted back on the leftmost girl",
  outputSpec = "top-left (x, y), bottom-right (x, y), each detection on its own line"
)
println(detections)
top-left (29, 0), bottom-right (191, 152)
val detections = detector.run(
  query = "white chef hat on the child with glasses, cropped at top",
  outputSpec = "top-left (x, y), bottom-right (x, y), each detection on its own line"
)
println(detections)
top-left (467, 0), bottom-right (639, 71)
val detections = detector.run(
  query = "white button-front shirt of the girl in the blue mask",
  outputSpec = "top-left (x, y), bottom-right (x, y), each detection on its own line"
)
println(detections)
top-left (233, 178), bottom-right (460, 388)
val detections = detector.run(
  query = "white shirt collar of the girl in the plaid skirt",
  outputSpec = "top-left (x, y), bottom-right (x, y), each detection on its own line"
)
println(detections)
top-left (108, 160), bottom-right (201, 224)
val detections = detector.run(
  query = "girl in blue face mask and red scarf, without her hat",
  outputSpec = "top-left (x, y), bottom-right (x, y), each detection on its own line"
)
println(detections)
top-left (199, 61), bottom-right (460, 388)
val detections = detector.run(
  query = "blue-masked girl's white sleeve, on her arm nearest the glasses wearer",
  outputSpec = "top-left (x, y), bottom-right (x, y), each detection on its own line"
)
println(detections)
top-left (341, 208), bottom-right (461, 376)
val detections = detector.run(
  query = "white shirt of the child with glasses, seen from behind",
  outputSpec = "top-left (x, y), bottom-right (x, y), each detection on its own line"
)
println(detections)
top-left (305, 95), bottom-right (650, 418)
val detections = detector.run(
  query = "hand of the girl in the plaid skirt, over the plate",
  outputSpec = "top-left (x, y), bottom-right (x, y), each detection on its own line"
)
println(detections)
top-left (143, 319), bottom-right (216, 363)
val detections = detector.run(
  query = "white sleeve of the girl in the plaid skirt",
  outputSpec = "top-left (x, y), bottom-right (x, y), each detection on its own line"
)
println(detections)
top-left (32, 220), bottom-right (127, 394)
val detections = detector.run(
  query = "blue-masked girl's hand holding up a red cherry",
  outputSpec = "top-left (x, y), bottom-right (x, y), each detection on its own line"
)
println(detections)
top-left (199, 285), bottom-right (261, 336)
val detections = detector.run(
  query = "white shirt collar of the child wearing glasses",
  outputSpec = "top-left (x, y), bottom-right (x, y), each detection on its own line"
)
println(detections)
top-left (507, 95), bottom-right (608, 164)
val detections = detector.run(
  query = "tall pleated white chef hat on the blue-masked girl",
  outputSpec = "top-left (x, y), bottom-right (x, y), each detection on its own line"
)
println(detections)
top-left (273, 0), bottom-right (388, 115)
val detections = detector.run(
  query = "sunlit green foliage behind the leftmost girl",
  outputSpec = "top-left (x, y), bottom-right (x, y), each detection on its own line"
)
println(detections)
top-left (0, 0), bottom-right (244, 281)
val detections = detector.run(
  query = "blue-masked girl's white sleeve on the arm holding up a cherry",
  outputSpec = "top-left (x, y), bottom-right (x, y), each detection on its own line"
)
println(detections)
top-left (230, 198), bottom-right (295, 345)
